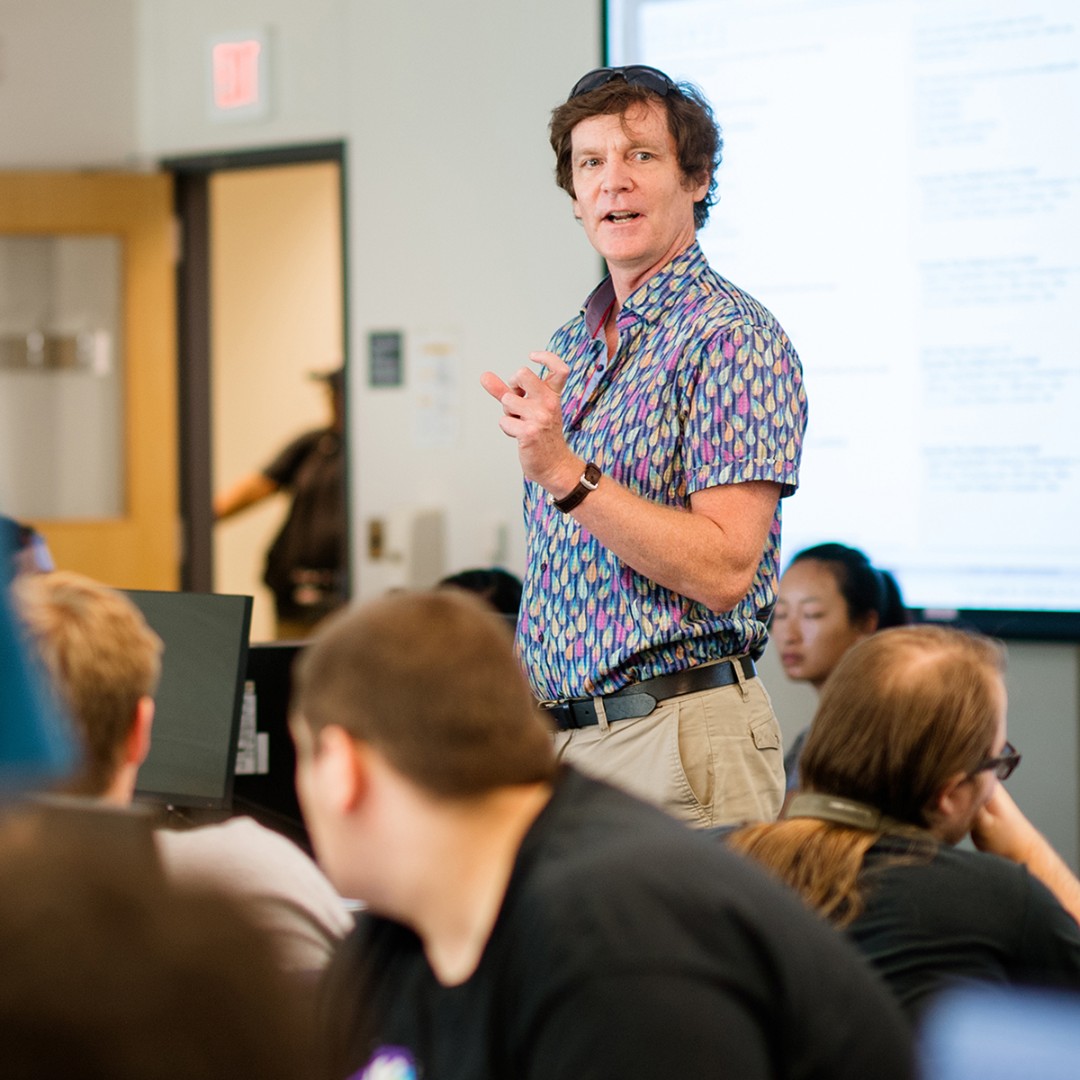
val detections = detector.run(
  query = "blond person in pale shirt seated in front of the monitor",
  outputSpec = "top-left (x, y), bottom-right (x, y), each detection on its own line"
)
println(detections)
top-left (12, 571), bottom-right (352, 971)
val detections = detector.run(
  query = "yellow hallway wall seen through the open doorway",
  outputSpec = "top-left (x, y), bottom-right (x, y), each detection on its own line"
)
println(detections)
top-left (211, 162), bottom-right (342, 640)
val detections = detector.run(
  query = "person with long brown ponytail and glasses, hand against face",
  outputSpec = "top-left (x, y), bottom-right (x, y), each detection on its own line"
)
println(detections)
top-left (727, 626), bottom-right (1080, 1021)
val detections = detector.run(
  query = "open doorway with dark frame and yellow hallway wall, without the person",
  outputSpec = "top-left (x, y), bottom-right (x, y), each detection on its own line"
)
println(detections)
top-left (163, 144), bottom-right (349, 640)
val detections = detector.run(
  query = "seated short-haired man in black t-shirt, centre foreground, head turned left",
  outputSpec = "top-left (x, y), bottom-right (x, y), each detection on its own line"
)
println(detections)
top-left (292, 589), bottom-right (909, 1080)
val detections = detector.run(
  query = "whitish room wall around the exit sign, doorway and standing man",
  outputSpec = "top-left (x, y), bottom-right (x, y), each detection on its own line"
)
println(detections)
top-left (0, 0), bottom-right (1078, 865)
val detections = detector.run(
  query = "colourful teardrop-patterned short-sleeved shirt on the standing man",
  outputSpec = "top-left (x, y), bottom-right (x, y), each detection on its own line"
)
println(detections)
top-left (517, 243), bottom-right (807, 700)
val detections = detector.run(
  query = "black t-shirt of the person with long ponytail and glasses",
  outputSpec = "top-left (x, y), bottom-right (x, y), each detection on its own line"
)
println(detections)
top-left (848, 836), bottom-right (1080, 1018)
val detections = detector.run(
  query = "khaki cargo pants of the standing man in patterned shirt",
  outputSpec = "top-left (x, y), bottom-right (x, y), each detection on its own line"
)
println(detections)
top-left (555, 672), bottom-right (784, 827)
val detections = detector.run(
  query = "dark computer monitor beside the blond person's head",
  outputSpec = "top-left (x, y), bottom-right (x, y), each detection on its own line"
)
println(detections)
top-left (125, 590), bottom-right (252, 810)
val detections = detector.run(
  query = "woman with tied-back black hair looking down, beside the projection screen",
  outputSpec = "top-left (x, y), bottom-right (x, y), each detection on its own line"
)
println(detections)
top-left (769, 543), bottom-right (909, 792)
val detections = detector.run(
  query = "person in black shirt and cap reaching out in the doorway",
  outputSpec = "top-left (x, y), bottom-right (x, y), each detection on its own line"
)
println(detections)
top-left (214, 368), bottom-right (349, 639)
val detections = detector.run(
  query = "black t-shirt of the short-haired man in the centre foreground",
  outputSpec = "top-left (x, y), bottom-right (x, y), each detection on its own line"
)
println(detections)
top-left (326, 769), bottom-right (910, 1080)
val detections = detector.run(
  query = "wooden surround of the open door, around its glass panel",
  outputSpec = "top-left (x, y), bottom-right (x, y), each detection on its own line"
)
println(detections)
top-left (0, 173), bottom-right (179, 590)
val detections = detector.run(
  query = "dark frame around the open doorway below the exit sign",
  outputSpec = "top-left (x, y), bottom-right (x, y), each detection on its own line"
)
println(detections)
top-left (159, 141), bottom-right (354, 596)
